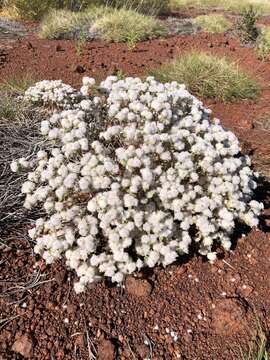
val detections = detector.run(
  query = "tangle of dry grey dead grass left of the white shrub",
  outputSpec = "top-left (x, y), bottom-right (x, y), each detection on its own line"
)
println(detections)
top-left (0, 93), bottom-right (45, 229)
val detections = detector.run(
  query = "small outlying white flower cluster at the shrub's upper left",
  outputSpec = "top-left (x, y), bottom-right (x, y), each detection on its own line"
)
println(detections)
top-left (24, 77), bottom-right (95, 109)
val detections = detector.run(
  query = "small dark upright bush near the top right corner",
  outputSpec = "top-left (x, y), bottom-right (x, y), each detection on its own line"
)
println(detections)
top-left (237, 6), bottom-right (259, 43)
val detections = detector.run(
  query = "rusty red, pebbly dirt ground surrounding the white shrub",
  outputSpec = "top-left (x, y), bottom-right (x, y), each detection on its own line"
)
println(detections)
top-left (0, 23), bottom-right (270, 360)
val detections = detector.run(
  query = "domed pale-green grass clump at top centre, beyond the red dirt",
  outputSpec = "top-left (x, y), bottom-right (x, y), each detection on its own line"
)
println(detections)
top-left (92, 9), bottom-right (167, 43)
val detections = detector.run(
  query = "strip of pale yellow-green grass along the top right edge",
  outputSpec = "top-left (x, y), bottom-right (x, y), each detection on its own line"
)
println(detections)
top-left (170, 0), bottom-right (270, 13)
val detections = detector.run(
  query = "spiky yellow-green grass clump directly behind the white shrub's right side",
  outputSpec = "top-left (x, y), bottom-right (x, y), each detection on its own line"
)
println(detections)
top-left (150, 52), bottom-right (260, 101)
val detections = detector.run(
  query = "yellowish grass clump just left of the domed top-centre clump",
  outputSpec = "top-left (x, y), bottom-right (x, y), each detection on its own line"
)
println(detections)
top-left (38, 6), bottom-right (109, 39)
